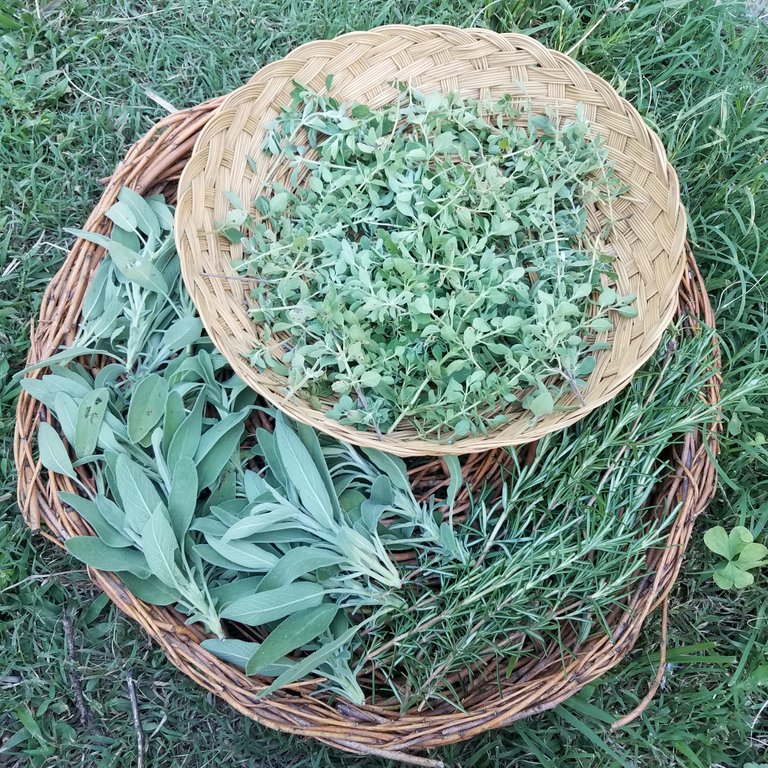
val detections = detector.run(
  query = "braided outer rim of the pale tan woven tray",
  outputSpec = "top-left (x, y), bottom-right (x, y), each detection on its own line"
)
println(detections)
top-left (176, 25), bottom-right (686, 456)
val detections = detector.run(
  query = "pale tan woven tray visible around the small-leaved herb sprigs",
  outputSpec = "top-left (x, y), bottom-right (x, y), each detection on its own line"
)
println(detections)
top-left (176, 26), bottom-right (686, 456)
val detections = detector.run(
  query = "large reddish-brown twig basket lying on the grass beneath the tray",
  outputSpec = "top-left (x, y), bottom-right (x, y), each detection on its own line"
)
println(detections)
top-left (14, 101), bottom-right (719, 766)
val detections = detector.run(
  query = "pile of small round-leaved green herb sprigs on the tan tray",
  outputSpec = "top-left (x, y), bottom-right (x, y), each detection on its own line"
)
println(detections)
top-left (222, 87), bottom-right (636, 441)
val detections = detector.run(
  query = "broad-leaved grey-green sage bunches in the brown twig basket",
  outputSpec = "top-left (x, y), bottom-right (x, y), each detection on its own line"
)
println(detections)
top-left (22, 190), bottom-right (462, 699)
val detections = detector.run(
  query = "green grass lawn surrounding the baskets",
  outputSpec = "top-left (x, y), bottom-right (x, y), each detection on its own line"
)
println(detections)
top-left (0, 0), bottom-right (768, 768)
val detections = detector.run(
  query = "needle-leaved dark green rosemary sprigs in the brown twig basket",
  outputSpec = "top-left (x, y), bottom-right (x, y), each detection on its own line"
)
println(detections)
top-left (366, 330), bottom-right (741, 710)
